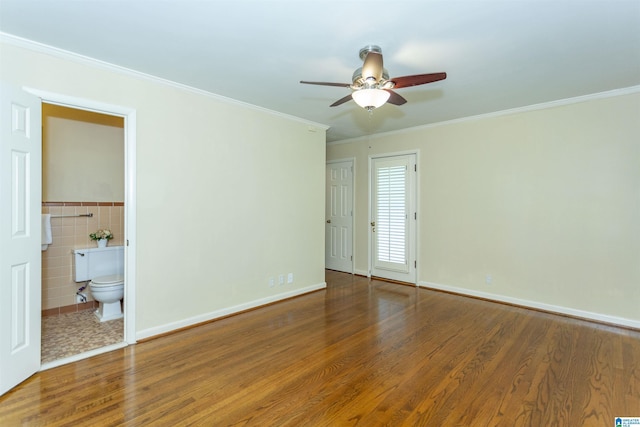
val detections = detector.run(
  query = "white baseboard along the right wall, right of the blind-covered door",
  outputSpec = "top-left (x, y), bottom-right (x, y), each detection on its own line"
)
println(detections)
top-left (418, 281), bottom-right (640, 329)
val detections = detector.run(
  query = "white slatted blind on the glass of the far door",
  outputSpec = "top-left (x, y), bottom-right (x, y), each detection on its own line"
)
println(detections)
top-left (375, 165), bottom-right (407, 264)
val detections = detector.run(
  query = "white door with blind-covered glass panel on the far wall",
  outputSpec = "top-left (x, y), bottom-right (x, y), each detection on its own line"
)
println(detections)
top-left (370, 154), bottom-right (417, 283)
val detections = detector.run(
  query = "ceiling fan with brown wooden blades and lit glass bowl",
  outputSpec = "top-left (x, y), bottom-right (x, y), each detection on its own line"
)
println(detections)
top-left (300, 45), bottom-right (447, 112)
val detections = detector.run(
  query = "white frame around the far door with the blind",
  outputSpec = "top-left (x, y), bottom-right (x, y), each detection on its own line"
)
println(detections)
top-left (367, 150), bottom-right (420, 286)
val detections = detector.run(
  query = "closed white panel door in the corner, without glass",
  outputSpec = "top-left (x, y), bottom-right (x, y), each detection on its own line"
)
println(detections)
top-left (325, 161), bottom-right (353, 273)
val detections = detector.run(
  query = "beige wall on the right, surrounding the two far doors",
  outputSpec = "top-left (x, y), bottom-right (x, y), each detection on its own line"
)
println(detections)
top-left (327, 91), bottom-right (640, 326)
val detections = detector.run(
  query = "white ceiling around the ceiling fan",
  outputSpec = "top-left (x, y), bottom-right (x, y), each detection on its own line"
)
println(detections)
top-left (0, 0), bottom-right (640, 141)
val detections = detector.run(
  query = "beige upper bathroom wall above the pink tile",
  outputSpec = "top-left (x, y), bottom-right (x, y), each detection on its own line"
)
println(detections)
top-left (42, 104), bottom-right (124, 202)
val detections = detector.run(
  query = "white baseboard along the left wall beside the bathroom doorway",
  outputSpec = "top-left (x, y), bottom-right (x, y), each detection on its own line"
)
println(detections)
top-left (136, 282), bottom-right (327, 340)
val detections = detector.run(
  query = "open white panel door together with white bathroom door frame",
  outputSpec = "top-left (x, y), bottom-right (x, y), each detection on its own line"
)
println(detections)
top-left (0, 82), bottom-right (136, 395)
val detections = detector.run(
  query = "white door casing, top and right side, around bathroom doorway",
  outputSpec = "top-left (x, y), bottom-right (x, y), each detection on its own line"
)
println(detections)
top-left (23, 87), bottom-right (136, 350)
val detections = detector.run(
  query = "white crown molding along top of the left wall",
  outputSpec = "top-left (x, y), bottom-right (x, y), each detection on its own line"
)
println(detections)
top-left (0, 31), bottom-right (330, 131)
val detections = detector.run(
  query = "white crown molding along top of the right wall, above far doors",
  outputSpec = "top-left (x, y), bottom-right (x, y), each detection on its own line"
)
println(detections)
top-left (327, 85), bottom-right (640, 145)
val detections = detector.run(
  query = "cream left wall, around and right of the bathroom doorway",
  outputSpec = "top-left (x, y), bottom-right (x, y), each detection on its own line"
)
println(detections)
top-left (0, 36), bottom-right (325, 337)
